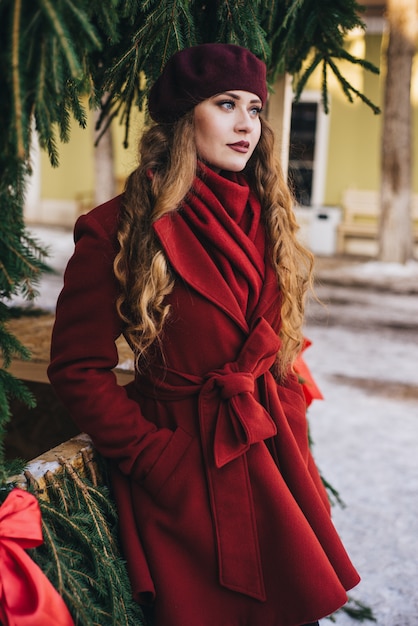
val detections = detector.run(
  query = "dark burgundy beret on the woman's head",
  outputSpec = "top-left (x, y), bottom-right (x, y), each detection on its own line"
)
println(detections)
top-left (148, 43), bottom-right (267, 122)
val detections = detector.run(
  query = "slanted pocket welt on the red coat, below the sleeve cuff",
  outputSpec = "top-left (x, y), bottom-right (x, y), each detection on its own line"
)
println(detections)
top-left (142, 426), bottom-right (193, 496)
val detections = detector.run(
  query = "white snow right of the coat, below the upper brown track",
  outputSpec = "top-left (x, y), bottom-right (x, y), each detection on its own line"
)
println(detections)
top-left (306, 327), bottom-right (418, 626)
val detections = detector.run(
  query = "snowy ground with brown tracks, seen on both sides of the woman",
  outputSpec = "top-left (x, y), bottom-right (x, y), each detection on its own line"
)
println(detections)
top-left (9, 228), bottom-right (418, 626)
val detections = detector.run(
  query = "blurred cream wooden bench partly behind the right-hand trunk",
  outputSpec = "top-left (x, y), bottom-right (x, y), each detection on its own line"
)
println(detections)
top-left (337, 189), bottom-right (418, 256)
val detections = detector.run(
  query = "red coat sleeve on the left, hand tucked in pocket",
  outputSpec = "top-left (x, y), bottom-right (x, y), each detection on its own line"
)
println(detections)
top-left (48, 204), bottom-right (173, 480)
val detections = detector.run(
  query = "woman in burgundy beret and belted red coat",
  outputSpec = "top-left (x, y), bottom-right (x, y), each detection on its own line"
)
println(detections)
top-left (49, 44), bottom-right (359, 626)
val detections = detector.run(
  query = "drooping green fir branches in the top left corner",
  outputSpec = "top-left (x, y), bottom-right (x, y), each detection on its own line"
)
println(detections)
top-left (0, 0), bottom-right (112, 165)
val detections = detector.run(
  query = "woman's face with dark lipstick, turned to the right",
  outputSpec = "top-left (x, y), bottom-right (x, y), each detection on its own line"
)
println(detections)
top-left (194, 90), bottom-right (262, 172)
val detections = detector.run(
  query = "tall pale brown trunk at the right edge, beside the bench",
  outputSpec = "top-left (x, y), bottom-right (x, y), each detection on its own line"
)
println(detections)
top-left (379, 0), bottom-right (418, 263)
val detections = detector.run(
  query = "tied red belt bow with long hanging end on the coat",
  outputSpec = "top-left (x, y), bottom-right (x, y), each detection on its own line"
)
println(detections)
top-left (199, 318), bottom-right (280, 600)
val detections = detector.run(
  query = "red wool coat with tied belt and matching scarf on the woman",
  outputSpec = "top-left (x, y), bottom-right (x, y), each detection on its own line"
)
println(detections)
top-left (49, 166), bottom-right (359, 626)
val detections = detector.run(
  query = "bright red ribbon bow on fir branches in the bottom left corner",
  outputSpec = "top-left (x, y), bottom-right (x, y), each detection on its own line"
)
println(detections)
top-left (0, 489), bottom-right (74, 626)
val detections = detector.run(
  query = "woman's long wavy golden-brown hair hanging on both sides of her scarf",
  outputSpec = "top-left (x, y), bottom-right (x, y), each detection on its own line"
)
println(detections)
top-left (114, 111), bottom-right (313, 376)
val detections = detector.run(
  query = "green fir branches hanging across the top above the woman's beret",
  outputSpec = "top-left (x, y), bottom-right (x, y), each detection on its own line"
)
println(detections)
top-left (0, 0), bottom-right (377, 165)
